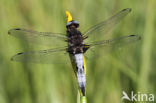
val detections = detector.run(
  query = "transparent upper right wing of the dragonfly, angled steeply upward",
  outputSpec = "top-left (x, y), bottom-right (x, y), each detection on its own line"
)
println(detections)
top-left (83, 8), bottom-right (131, 41)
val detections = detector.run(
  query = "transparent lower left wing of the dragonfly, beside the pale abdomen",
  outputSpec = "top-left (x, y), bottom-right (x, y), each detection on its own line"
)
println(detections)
top-left (11, 47), bottom-right (69, 64)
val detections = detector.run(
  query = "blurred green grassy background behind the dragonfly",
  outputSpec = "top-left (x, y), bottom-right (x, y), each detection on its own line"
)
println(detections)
top-left (0, 0), bottom-right (156, 103)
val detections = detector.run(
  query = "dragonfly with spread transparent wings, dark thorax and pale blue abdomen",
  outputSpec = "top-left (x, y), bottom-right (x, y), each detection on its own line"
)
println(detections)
top-left (8, 8), bottom-right (141, 96)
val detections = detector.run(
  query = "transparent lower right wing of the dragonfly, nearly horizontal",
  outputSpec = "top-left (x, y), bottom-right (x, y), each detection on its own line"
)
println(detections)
top-left (85, 35), bottom-right (141, 58)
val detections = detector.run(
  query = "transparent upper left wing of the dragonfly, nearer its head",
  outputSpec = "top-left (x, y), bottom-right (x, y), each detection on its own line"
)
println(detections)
top-left (8, 28), bottom-right (67, 46)
